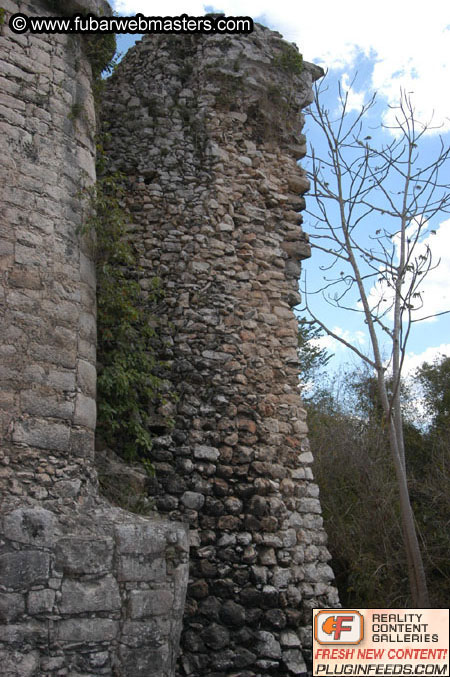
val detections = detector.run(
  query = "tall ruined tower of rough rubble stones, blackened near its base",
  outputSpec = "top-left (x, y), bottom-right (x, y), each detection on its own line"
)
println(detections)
top-left (104, 26), bottom-right (337, 677)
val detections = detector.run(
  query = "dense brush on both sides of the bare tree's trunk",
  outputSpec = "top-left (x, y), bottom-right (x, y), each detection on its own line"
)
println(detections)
top-left (306, 368), bottom-right (450, 608)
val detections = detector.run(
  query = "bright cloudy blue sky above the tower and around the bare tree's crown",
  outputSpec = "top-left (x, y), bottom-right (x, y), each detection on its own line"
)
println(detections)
top-left (112, 0), bottom-right (450, 380)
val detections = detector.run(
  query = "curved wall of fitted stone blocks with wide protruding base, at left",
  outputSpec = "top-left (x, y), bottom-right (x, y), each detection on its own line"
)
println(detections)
top-left (0, 0), bottom-right (188, 677)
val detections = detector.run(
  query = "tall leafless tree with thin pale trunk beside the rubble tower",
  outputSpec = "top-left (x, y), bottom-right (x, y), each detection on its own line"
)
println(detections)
top-left (303, 80), bottom-right (450, 607)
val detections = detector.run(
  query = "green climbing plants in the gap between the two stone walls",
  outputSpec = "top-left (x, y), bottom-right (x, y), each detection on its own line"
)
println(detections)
top-left (80, 164), bottom-right (170, 469)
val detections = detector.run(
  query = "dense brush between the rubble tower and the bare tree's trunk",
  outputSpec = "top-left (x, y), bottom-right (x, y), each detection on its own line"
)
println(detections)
top-left (307, 382), bottom-right (407, 608)
